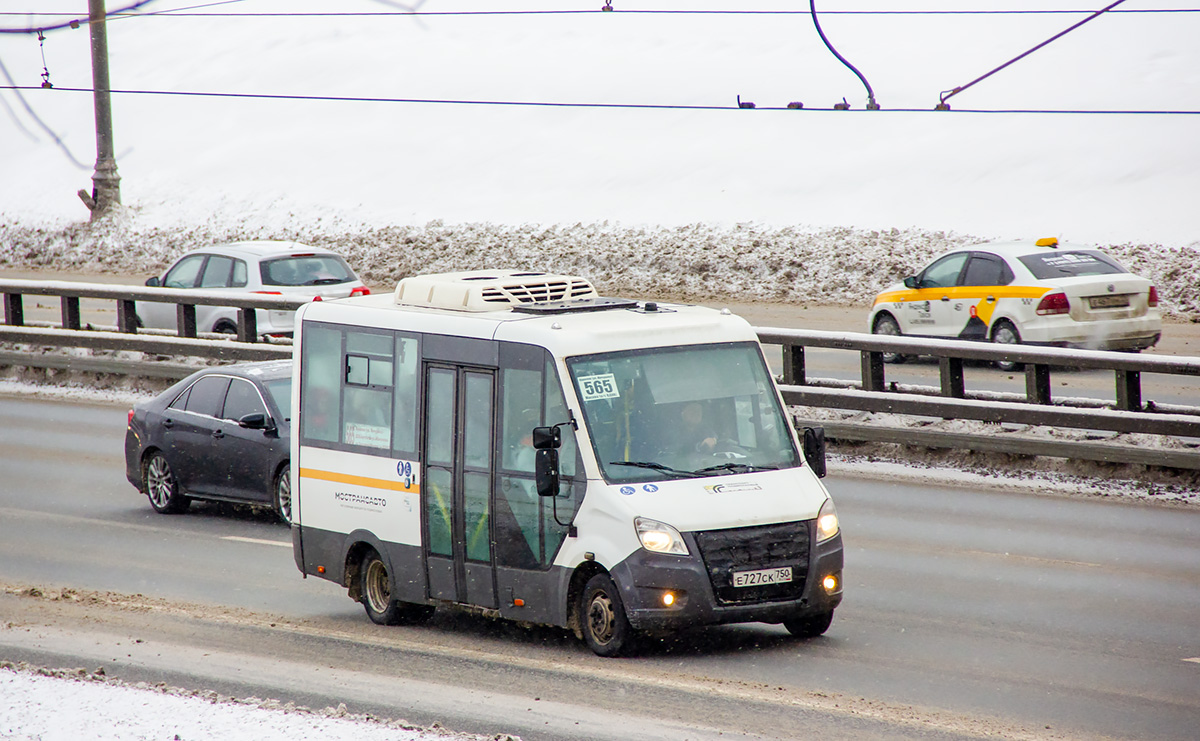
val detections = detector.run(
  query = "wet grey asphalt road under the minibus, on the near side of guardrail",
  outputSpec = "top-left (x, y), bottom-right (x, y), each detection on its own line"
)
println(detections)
top-left (0, 397), bottom-right (1200, 741)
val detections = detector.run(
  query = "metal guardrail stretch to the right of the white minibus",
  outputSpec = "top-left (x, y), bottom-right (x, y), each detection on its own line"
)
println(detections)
top-left (757, 327), bottom-right (1200, 469)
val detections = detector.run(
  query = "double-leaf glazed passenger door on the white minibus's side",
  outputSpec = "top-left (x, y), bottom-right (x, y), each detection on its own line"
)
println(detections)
top-left (422, 363), bottom-right (497, 608)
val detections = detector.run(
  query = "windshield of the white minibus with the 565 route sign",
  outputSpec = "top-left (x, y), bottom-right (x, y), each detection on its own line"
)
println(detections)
top-left (568, 342), bottom-right (800, 483)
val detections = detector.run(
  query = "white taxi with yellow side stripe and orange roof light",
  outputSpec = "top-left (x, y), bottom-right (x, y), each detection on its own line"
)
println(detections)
top-left (869, 237), bottom-right (1163, 369)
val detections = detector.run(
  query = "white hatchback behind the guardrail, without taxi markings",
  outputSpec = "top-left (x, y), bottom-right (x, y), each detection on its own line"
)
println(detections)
top-left (137, 241), bottom-right (371, 337)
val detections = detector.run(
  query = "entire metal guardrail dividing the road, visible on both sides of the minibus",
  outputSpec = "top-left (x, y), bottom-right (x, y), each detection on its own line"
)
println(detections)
top-left (0, 279), bottom-right (1200, 469)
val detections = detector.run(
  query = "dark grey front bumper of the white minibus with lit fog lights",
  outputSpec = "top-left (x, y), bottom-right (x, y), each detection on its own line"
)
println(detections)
top-left (612, 525), bottom-right (844, 632)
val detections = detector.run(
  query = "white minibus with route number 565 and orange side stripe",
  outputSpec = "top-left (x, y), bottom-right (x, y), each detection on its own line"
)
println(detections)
top-left (292, 270), bottom-right (842, 656)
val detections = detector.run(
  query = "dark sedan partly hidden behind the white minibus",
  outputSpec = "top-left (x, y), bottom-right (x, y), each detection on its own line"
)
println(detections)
top-left (125, 360), bottom-right (292, 523)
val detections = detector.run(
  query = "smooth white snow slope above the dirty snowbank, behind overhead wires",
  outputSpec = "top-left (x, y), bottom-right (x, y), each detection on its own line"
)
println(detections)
top-left (0, 0), bottom-right (1200, 246)
